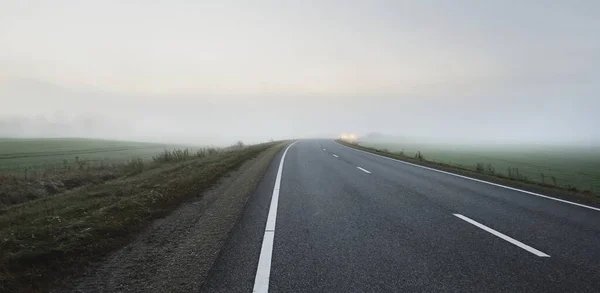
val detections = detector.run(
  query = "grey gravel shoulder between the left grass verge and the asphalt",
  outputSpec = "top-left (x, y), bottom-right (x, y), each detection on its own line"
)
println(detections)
top-left (52, 144), bottom-right (285, 293)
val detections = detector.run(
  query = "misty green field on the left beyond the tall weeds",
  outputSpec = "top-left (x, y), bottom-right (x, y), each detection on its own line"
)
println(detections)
top-left (0, 138), bottom-right (190, 174)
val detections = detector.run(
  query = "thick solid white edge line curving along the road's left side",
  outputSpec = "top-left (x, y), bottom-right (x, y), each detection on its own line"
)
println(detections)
top-left (252, 141), bottom-right (297, 293)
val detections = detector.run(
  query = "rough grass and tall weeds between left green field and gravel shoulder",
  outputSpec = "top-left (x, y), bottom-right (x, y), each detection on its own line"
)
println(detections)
top-left (0, 142), bottom-right (279, 292)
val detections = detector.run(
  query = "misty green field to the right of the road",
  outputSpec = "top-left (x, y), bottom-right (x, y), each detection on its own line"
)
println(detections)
top-left (359, 140), bottom-right (600, 193)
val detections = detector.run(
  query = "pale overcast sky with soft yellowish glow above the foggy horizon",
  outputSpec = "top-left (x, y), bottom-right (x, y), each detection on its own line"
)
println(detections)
top-left (0, 0), bottom-right (600, 144)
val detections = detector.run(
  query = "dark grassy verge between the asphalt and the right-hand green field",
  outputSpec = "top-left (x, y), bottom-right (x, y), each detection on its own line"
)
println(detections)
top-left (336, 140), bottom-right (600, 205)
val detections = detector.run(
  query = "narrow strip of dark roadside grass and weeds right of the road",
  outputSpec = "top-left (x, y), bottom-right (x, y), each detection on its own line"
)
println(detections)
top-left (338, 140), bottom-right (600, 203)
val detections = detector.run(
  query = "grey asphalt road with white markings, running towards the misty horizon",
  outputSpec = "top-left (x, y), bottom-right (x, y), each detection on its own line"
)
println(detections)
top-left (200, 140), bottom-right (600, 292)
